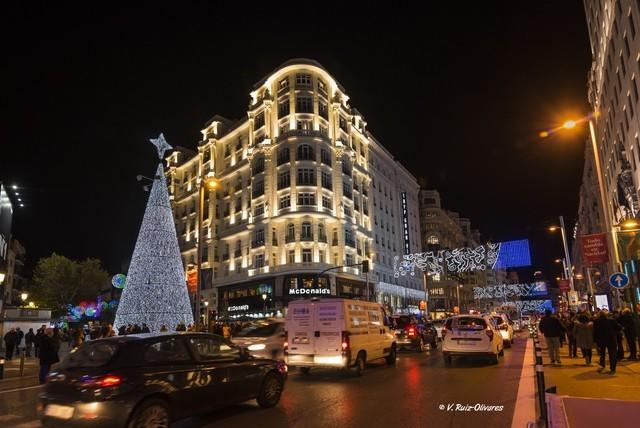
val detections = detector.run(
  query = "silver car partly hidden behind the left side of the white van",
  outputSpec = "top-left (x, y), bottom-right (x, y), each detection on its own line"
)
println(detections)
top-left (231, 319), bottom-right (285, 359)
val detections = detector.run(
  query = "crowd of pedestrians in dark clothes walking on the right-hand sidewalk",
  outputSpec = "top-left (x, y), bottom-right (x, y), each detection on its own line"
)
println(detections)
top-left (539, 308), bottom-right (640, 374)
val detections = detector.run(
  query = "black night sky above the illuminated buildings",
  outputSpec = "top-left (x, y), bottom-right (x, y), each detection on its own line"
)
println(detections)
top-left (0, 0), bottom-right (591, 276)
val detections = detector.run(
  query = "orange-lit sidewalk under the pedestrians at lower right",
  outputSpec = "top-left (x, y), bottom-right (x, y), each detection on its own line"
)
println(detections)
top-left (540, 338), bottom-right (640, 428)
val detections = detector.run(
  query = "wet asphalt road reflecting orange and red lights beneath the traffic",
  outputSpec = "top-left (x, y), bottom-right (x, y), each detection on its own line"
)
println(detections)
top-left (0, 339), bottom-right (525, 428)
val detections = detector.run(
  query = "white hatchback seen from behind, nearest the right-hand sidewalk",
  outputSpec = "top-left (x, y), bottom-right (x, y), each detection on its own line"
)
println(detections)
top-left (442, 315), bottom-right (504, 364)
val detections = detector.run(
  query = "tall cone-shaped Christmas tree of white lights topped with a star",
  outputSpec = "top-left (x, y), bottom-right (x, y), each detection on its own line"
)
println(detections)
top-left (114, 134), bottom-right (193, 331)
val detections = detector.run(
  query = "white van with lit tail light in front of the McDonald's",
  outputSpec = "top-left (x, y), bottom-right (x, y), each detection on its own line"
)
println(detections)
top-left (284, 298), bottom-right (396, 375)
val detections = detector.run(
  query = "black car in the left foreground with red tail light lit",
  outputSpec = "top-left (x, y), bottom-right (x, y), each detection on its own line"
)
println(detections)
top-left (39, 333), bottom-right (287, 427)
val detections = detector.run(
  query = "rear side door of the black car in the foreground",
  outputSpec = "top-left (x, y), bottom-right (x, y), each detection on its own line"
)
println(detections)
top-left (143, 336), bottom-right (198, 417)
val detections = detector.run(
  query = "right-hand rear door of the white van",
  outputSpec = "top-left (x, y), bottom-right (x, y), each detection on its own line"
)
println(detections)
top-left (314, 300), bottom-right (344, 355)
